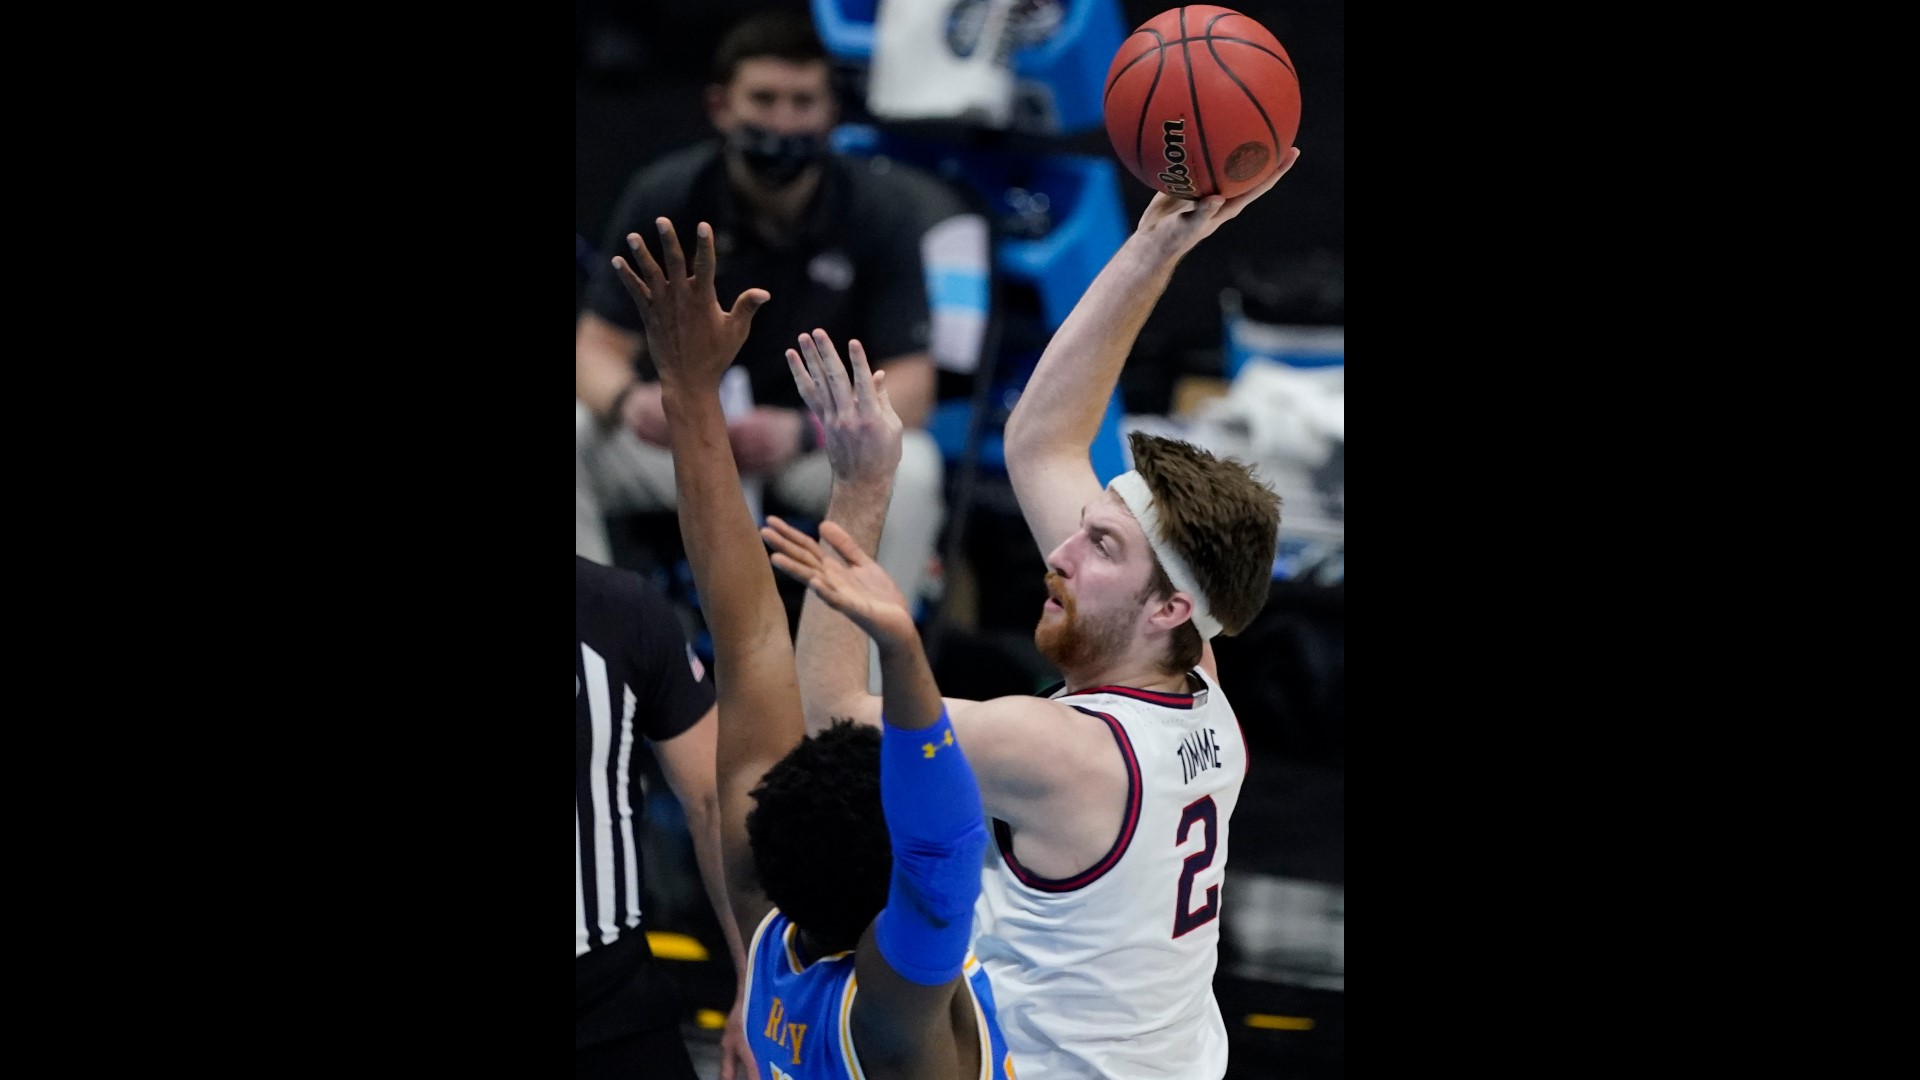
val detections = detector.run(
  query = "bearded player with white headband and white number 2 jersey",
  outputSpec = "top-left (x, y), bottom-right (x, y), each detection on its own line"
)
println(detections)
top-left (762, 150), bottom-right (1298, 1080)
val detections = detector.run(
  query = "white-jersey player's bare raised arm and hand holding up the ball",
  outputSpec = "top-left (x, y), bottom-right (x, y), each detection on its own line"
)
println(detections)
top-left (1006, 148), bottom-right (1300, 553)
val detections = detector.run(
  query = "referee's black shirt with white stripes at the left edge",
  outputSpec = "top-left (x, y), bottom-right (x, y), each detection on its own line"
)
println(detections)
top-left (574, 555), bottom-right (714, 959)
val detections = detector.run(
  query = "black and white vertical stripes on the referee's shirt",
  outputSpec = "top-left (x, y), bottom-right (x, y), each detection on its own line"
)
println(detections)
top-left (574, 642), bottom-right (641, 957)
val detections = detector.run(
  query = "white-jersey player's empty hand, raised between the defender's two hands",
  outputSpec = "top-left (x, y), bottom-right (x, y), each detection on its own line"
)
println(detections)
top-left (787, 331), bottom-right (900, 484)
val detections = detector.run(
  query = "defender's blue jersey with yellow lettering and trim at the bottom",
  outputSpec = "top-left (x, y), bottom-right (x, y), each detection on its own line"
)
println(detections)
top-left (745, 907), bottom-right (1014, 1080)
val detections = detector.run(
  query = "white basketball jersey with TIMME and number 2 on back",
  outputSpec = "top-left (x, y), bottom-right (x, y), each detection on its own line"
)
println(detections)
top-left (973, 671), bottom-right (1248, 1080)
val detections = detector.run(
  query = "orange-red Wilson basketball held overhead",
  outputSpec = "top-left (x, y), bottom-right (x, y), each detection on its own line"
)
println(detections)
top-left (1102, 4), bottom-right (1300, 198)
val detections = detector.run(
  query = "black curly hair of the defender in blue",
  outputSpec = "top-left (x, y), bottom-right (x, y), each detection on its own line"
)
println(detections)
top-left (747, 721), bottom-right (893, 953)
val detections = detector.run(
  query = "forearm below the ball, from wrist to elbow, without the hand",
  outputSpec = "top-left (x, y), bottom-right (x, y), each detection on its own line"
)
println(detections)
top-left (1006, 236), bottom-right (1177, 455)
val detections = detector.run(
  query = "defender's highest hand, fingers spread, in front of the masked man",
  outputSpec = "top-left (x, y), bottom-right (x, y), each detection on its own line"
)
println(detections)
top-left (612, 217), bottom-right (770, 388)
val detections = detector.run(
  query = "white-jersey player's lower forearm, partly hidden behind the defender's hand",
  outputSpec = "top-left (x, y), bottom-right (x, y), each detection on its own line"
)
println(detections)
top-left (793, 479), bottom-right (893, 732)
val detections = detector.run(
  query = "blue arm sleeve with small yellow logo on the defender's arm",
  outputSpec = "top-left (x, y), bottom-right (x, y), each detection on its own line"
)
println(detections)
top-left (874, 709), bottom-right (987, 986)
